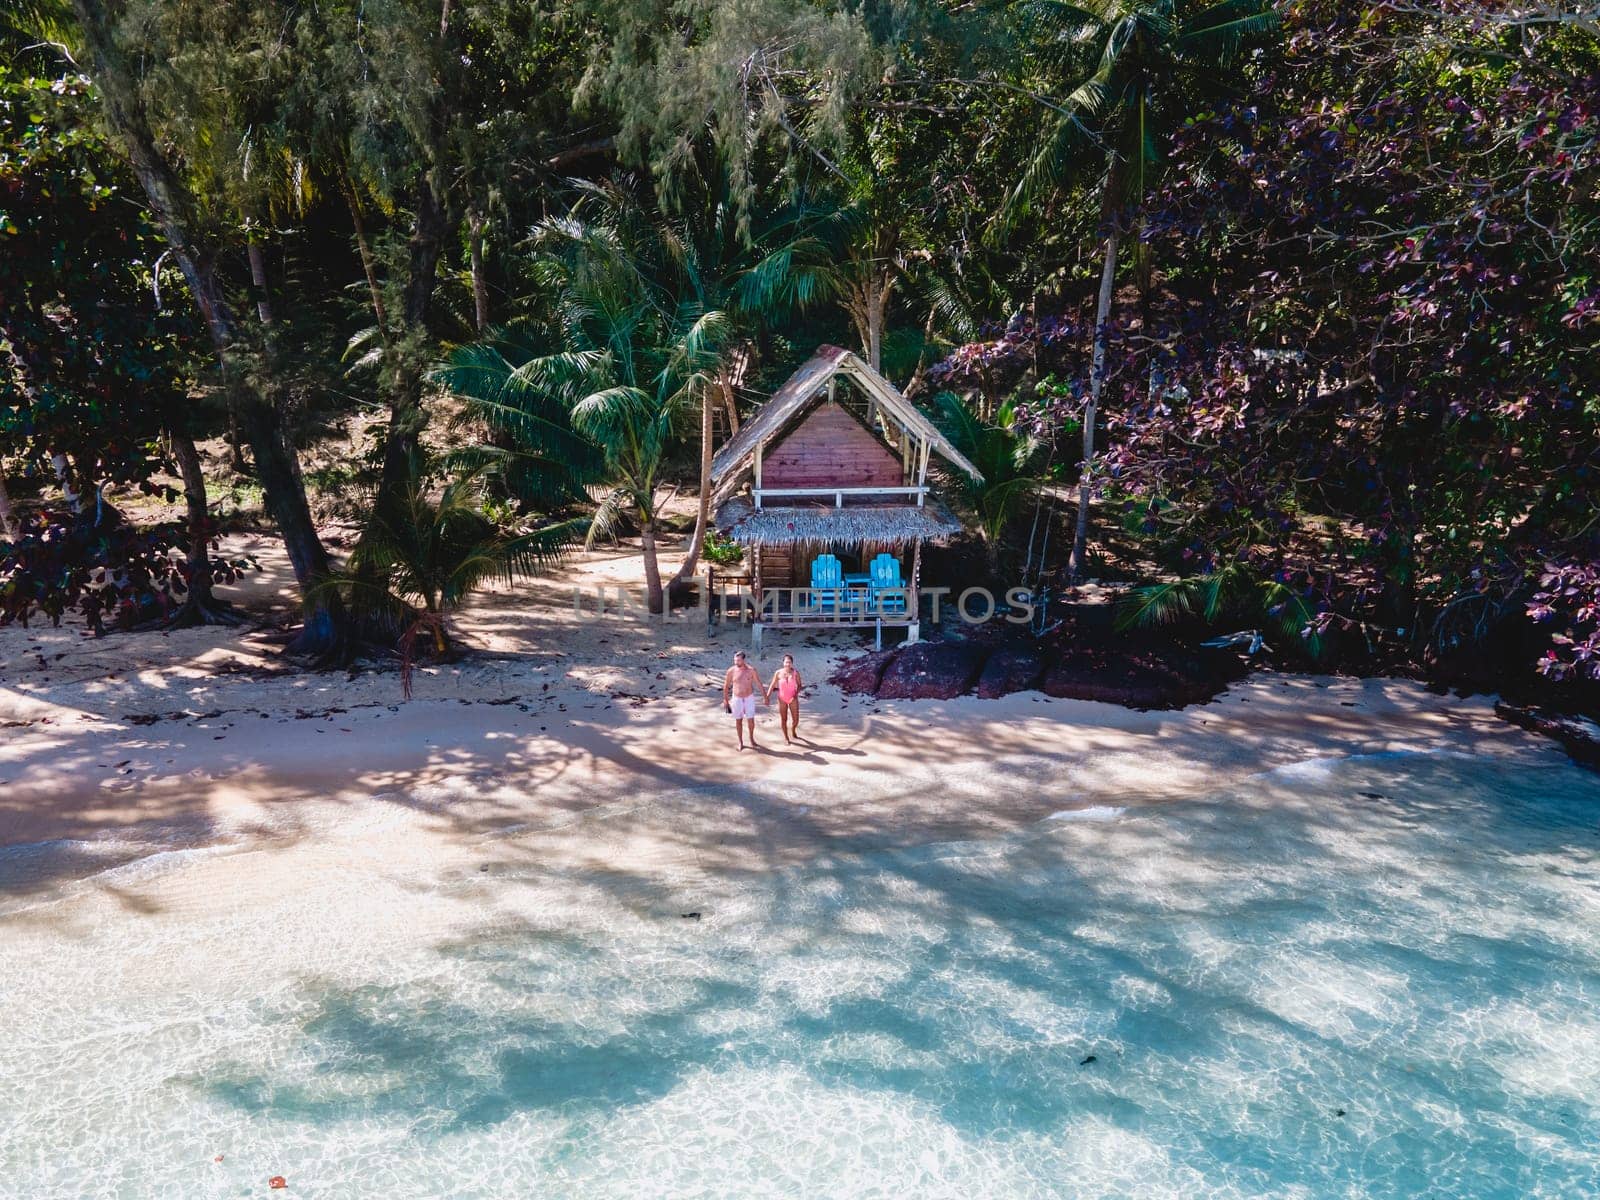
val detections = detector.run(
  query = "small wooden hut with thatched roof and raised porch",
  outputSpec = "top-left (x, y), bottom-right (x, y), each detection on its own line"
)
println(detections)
top-left (712, 346), bottom-right (982, 645)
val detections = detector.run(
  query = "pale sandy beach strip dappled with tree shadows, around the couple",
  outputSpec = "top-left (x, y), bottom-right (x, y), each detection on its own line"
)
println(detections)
top-left (0, 541), bottom-right (1552, 890)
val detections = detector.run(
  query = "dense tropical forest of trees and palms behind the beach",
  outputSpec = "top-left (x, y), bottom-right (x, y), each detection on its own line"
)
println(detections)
top-left (0, 0), bottom-right (1600, 694)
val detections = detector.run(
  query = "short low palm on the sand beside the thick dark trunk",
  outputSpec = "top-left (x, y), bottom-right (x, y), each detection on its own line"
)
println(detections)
top-left (330, 456), bottom-right (584, 696)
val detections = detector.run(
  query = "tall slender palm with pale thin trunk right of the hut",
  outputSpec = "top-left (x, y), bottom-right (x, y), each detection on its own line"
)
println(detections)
top-left (1006, 0), bottom-right (1278, 578)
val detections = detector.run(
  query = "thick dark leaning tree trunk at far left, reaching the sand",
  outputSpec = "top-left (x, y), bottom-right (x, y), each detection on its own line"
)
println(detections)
top-left (72, 0), bottom-right (349, 661)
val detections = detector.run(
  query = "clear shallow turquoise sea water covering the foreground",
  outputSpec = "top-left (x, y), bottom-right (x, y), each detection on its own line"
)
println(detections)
top-left (0, 755), bottom-right (1600, 1200)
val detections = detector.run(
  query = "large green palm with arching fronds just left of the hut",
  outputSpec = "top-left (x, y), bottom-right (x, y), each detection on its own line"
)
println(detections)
top-left (434, 181), bottom-right (832, 613)
